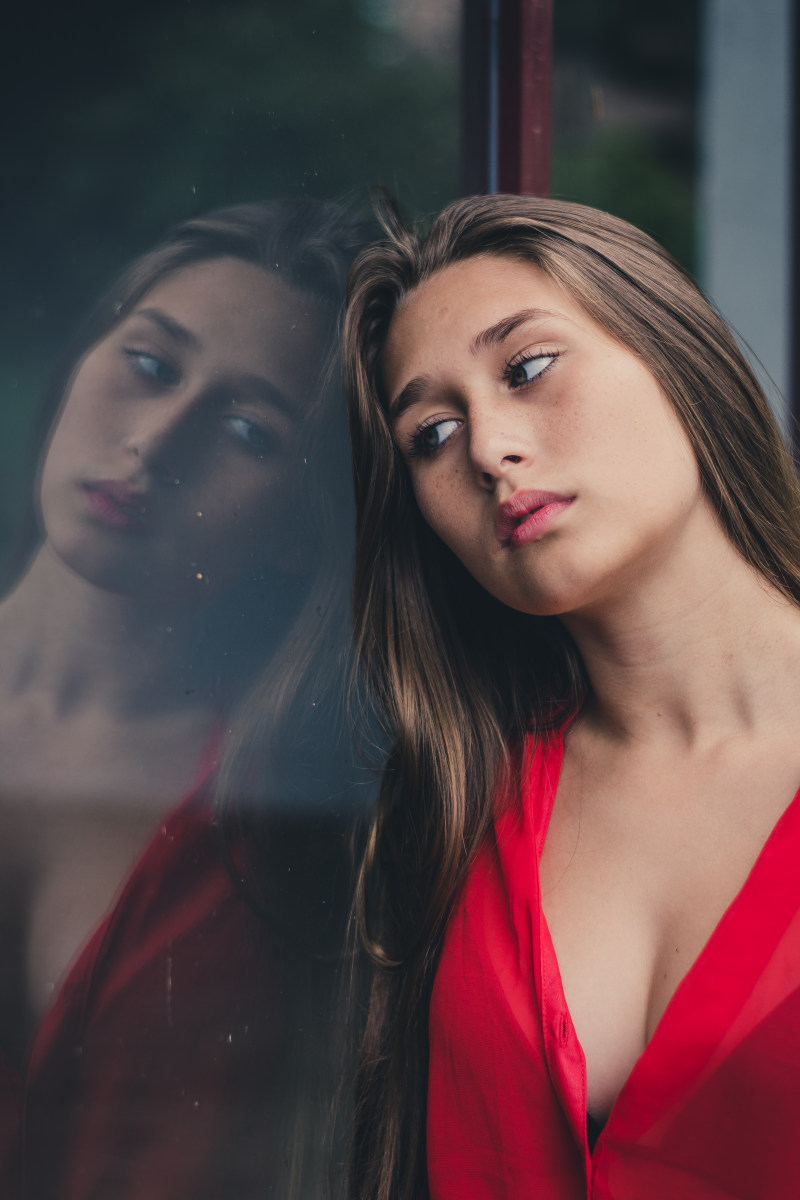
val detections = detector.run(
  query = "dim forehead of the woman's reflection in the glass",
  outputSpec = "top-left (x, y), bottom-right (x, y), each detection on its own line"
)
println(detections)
top-left (128, 258), bottom-right (323, 370)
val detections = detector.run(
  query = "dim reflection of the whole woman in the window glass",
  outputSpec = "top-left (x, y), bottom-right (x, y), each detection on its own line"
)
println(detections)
top-left (0, 202), bottom-right (355, 1200)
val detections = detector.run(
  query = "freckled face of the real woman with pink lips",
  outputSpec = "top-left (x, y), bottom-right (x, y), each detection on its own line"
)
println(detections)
top-left (383, 256), bottom-right (709, 616)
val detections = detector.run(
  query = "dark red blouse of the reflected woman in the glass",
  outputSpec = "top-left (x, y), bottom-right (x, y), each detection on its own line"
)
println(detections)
top-left (0, 763), bottom-right (283, 1200)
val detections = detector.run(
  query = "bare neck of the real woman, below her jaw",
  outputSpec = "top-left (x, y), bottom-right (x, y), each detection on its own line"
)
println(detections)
top-left (564, 533), bottom-right (800, 749)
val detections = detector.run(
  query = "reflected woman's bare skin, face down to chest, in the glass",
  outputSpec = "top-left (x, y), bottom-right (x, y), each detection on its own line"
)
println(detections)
top-left (0, 258), bottom-right (320, 1040)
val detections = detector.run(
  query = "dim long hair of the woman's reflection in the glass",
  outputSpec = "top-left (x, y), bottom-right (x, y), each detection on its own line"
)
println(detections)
top-left (3, 199), bottom-right (367, 1195)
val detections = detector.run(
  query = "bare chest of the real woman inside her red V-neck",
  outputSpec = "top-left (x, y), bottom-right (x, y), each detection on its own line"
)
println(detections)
top-left (540, 746), bottom-right (800, 1117)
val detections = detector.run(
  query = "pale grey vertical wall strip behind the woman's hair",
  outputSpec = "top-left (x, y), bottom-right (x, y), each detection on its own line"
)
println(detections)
top-left (699, 0), bottom-right (792, 428)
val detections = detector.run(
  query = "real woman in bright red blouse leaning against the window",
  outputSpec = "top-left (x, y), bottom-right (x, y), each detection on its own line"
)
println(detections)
top-left (348, 197), bottom-right (800, 1200)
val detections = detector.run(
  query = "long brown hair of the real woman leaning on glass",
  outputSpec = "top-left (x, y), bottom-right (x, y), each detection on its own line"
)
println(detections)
top-left (344, 196), bottom-right (800, 1200)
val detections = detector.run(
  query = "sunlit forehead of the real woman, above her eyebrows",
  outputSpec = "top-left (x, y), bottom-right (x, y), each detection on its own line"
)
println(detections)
top-left (383, 254), bottom-right (589, 386)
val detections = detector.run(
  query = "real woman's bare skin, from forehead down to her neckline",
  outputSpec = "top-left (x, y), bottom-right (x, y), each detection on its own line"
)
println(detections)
top-left (384, 256), bottom-right (800, 1117)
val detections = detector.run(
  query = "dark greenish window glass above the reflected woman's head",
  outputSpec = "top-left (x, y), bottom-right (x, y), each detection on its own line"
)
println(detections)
top-left (0, 0), bottom-right (459, 549)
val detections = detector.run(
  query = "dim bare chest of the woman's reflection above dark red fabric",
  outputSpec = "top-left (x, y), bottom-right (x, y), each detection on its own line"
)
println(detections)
top-left (0, 705), bottom-right (212, 1060)
